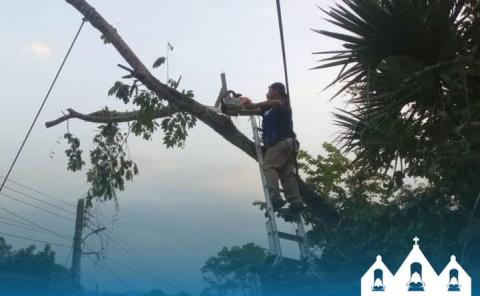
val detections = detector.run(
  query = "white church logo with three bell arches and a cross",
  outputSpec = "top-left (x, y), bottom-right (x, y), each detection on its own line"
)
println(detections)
top-left (361, 237), bottom-right (472, 296)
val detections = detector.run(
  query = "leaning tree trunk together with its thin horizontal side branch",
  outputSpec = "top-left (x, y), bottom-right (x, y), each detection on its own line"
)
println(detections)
top-left (46, 0), bottom-right (338, 225)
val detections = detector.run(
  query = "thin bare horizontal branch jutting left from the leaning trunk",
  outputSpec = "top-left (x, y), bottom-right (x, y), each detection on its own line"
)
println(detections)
top-left (45, 107), bottom-right (178, 128)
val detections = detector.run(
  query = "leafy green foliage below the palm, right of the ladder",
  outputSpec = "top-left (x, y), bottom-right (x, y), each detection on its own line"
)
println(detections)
top-left (300, 144), bottom-right (480, 295)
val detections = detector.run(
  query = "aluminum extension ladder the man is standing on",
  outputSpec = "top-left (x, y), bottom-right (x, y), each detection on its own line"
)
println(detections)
top-left (250, 116), bottom-right (308, 261)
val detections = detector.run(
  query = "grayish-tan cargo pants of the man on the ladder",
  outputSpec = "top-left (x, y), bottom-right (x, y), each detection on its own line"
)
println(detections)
top-left (263, 138), bottom-right (302, 204)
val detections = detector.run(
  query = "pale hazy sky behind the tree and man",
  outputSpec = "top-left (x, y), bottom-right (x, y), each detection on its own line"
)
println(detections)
top-left (0, 0), bottom-right (343, 292)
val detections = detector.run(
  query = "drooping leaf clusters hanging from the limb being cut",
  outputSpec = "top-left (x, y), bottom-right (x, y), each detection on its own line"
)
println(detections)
top-left (64, 57), bottom-right (197, 207)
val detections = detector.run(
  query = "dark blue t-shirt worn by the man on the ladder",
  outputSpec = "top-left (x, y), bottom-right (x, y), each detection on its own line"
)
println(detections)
top-left (262, 99), bottom-right (296, 146)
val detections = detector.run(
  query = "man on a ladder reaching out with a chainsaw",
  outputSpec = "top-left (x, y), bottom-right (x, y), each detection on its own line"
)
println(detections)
top-left (241, 82), bottom-right (303, 212)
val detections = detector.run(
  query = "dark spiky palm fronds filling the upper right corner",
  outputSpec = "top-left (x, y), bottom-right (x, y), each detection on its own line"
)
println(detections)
top-left (317, 0), bottom-right (480, 205)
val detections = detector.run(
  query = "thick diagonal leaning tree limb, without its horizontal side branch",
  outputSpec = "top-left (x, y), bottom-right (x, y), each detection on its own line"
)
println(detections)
top-left (60, 0), bottom-right (338, 224)
